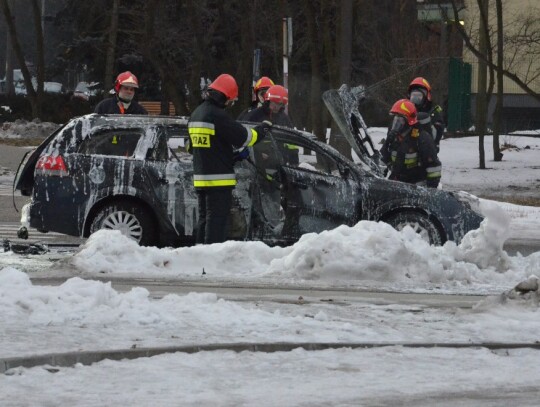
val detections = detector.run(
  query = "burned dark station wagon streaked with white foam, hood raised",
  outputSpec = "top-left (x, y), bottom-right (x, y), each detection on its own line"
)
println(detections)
top-left (15, 114), bottom-right (482, 246)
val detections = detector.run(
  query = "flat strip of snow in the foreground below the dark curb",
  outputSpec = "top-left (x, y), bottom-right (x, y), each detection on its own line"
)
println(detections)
top-left (0, 347), bottom-right (540, 407)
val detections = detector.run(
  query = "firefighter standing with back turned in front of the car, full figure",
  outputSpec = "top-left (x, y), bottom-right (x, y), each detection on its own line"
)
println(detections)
top-left (188, 74), bottom-right (272, 244)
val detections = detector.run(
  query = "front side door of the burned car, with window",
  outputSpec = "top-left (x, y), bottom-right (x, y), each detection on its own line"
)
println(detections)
top-left (256, 136), bottom-right (360, 242)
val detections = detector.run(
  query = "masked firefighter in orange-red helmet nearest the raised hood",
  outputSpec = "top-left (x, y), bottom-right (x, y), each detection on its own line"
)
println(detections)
top-left (381, 99), bottom-right (441, 188)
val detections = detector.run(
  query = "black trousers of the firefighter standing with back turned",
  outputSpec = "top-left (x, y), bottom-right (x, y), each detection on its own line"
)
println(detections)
top-left (197, 188), bottom-right (232, 244)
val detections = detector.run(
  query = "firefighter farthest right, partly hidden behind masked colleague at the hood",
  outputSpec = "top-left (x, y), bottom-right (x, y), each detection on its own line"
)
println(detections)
top-left (407, 77), bottom-right (444, 152)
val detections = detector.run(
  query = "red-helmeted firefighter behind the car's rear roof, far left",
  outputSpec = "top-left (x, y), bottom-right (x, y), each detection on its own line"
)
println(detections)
top-left (94, 71), bottom-right (148, 114)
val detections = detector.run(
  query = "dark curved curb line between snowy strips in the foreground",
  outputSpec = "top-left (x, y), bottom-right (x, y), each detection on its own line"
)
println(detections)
top-left (4, 342), bottom-right (540, 373)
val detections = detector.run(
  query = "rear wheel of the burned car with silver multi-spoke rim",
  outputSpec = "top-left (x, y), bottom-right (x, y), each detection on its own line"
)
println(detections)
top-left (90, 202), bottom-right (157, 246)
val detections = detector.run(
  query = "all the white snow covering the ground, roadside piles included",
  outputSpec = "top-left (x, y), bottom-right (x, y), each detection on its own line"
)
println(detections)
top-left (0, 122), bottom-right (540, 406)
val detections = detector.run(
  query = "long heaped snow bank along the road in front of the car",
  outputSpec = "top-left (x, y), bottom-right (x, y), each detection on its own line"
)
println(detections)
top-left (70, 207), bottom-right (540, 287)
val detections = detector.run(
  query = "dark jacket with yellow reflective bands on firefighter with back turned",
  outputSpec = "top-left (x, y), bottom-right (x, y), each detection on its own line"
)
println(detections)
top-left (188, 99), bottom-right (259, 188)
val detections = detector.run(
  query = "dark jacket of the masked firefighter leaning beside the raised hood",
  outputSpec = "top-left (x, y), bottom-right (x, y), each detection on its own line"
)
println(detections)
top-left (381, 127), bottom-right (442, 188)
